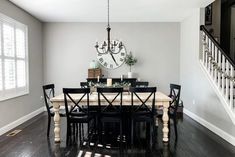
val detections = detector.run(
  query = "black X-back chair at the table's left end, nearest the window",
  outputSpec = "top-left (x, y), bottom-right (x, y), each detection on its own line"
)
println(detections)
top-left (42, 84), bottom-right (66, 137)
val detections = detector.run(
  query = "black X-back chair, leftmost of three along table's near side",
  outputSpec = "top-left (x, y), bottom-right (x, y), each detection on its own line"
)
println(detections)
top-left (63, 88), bottom-right (93, 144)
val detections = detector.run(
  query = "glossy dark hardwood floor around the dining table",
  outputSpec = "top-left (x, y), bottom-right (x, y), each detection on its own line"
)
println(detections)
top-left (0, 113), bottom-right (235, 157)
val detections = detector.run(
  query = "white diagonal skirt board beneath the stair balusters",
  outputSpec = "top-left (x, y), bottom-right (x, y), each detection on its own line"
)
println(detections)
top-left (199, 61), bottom-right (235, 125)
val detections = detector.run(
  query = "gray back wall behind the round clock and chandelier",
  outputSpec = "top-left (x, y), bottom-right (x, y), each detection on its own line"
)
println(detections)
top-left (43, 23), bottom-right (180, 93)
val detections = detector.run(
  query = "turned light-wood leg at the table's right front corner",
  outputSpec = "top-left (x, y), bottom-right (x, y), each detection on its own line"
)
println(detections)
top-left (162, 102), bottom-right (169, 142)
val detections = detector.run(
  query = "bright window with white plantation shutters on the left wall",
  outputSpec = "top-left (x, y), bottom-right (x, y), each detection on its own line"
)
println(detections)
top-left (0, 14), bottom-right (29, 101)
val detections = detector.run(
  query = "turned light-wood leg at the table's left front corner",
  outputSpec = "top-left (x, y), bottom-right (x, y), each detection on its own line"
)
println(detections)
top-left (53, 103), bottom-right (60, 142)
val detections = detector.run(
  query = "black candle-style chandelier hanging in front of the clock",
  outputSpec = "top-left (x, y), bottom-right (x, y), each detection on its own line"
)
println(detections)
top-left (95, 0), bottom-right (124, 54)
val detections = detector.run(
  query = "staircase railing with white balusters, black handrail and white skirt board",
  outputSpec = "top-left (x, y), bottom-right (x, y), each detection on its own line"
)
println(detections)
top-left (200, 26), bottom-right (235, 125)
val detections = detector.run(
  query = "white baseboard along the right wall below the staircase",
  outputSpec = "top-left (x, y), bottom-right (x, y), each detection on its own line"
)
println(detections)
top-left (184, 108), bottom-right (235, 146)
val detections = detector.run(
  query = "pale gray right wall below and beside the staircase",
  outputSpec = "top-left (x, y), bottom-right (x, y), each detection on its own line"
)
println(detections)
top-left (180, 9), bottom-right (235, 137)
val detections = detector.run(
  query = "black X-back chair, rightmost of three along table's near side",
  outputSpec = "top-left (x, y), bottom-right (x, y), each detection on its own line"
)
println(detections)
top-left (130, 87), bottom-right (157, 146)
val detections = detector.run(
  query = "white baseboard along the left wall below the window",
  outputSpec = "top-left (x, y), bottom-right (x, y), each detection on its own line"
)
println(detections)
top-left (0, 107), bottom-right (44, 136)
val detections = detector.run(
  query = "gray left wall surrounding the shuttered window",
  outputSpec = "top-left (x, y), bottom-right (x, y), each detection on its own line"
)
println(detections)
top-left (0, 0), bottom-right (43, 128)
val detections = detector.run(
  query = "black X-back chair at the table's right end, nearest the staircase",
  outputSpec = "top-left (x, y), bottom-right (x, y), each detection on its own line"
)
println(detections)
top-left (157, 84), bottom-right (181, 140)
